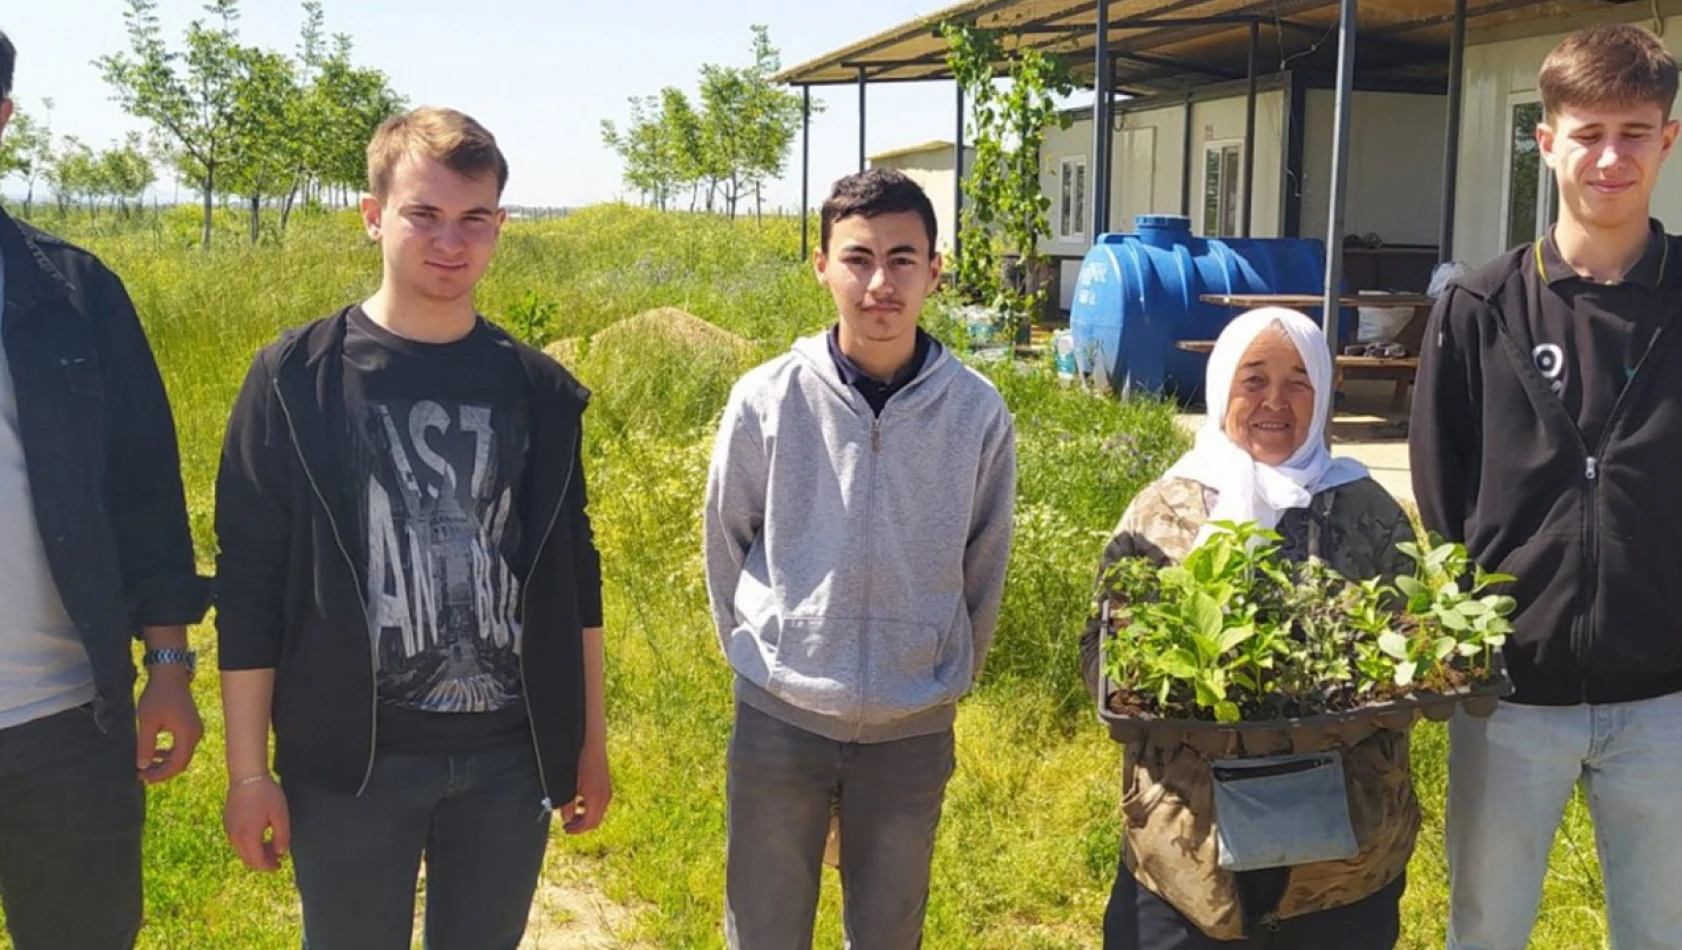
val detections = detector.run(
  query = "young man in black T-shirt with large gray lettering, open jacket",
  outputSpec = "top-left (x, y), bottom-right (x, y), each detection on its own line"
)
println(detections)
top-left (215, 108), bottom-right (612, 950)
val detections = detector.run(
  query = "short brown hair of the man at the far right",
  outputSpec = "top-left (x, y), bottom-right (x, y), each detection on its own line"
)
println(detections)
top-left (1536, 24), bottom-right (1677, 119)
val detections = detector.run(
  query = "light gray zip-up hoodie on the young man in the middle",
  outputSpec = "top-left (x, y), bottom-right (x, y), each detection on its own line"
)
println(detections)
top-left (703, 333), bottom-right (1016, 742)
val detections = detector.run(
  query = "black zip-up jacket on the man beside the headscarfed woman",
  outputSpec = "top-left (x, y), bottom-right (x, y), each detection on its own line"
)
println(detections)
top-left (1411, 230), bottom-right (1682, 705)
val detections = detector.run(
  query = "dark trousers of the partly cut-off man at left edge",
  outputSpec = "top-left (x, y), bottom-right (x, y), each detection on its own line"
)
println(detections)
top-left (0, 705), bottom-right (146, 950)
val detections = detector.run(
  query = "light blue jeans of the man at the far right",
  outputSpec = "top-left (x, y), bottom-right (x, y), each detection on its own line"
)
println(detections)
top-left (1447, 694), bottom-right (1682, 950)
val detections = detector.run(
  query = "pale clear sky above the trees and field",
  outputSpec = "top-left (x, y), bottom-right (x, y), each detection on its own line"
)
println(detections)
top-left (0, 0), bottom-right (995, 207)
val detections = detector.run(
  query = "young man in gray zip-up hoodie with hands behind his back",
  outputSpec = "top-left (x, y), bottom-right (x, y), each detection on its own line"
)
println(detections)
top-left (703, 168), bottom-right (1016, 950)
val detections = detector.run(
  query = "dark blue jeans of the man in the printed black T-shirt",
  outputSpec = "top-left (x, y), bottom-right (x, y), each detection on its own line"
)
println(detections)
top-left (286, 747), bottom-right (550, 950)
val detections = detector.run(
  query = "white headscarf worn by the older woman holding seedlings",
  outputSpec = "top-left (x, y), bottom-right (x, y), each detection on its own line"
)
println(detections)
top-left (1167, 306), bottom-right (1367, 545)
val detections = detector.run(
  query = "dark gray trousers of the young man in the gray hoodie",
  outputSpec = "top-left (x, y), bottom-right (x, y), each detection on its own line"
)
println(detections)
top-left (725, 703), bottom-right (955, 950)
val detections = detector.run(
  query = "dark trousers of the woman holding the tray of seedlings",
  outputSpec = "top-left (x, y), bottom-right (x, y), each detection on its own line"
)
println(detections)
top-left (1103, 850), bottom-right (1408, 950)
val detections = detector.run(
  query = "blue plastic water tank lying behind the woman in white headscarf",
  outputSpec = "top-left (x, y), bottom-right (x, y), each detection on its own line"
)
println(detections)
top-left (1070, 215), bottom-right (1354, 402)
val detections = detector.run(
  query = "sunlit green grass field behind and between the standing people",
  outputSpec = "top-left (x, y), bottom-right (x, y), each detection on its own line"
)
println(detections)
top-left (0, 207), bottom-right (1605, 950)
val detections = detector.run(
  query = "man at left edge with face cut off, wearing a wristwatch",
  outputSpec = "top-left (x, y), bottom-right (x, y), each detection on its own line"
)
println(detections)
top-left (0, 34), bottom-right (210, 950)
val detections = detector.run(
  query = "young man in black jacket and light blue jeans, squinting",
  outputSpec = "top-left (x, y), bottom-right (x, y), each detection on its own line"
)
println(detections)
top-left (1413, 24), bottom-right (1682, 950)
